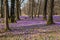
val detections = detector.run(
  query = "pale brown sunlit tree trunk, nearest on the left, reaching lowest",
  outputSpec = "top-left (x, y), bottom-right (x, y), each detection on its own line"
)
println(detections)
top-left (3, 0), bottom-right (10, 31)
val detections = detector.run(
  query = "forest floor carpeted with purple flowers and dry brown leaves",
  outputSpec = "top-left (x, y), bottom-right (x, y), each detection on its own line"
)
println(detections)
top-left (0, 16), bottom-right (60, 40)
